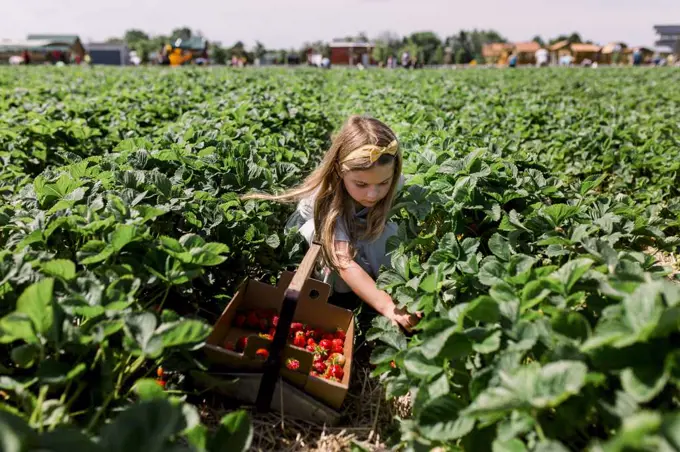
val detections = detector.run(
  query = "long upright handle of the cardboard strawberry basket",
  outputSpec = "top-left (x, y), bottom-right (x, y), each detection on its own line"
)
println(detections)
top-left (255, 242), bottom-right (321, 412)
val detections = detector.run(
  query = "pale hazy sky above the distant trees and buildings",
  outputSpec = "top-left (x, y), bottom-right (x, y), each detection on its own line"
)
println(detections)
top-left (0, 0), bottom-right (680, 48)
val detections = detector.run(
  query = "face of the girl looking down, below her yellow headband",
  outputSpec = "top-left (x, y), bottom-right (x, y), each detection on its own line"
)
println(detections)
top-left (342, 162), bottom-right (394, 207)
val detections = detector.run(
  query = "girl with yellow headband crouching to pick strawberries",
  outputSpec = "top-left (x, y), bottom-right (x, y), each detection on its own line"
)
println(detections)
top-left (244, 116), bottom-right (418, 331)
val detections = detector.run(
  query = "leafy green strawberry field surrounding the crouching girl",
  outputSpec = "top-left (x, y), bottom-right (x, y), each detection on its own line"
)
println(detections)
top-left (0, 68), bottom-right (680, 452)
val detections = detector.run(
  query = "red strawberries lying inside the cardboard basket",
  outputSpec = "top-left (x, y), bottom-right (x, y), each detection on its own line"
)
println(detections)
top-left (224, 309), bottom-right (346, 382)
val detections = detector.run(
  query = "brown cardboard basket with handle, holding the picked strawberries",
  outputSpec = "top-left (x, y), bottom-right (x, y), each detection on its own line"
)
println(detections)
top-left (199, 243), bottom-right (354, 420)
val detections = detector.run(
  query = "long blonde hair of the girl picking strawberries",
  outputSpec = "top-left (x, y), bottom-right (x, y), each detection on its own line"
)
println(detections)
top-left (242, 115), bottom-right (402, 269)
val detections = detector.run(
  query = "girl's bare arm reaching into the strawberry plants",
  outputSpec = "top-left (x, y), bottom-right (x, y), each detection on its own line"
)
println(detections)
top-left (335, 240), bottom-right (418, 331)
